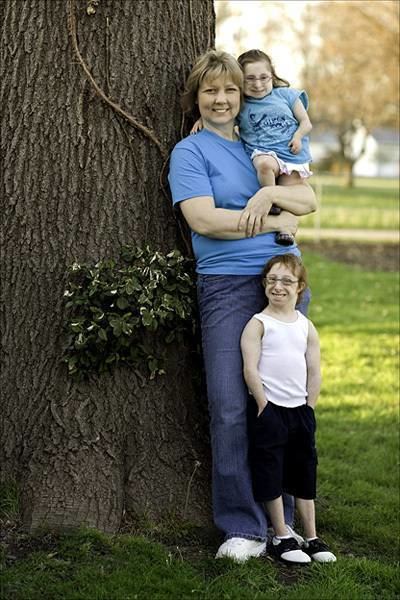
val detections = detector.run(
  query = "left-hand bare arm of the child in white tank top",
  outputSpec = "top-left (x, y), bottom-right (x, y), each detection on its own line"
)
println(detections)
top-left (240, 319), bottom-right (267, 414)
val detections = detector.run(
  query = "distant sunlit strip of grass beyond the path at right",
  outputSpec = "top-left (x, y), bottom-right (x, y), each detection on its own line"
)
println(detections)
top-left (301, 175), bottom-right (399, 230)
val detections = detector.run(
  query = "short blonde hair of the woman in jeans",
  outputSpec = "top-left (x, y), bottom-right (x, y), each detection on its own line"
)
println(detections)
top-left (181, 50), bottom-right (243, 113)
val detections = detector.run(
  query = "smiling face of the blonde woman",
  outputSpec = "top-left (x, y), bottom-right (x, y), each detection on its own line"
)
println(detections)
top-left (197, 76), bottom-right (240, 130)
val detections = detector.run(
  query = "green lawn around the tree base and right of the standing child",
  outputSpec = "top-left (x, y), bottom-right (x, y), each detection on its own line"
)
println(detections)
top-left (2, 254), bottom-right (400, 600)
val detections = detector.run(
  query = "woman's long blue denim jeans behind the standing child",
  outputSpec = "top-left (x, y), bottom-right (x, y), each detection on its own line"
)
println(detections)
top-left (197, 275), bottom-right (310, 540)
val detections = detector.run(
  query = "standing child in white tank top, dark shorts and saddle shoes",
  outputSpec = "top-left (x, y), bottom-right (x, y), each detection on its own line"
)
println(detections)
top-left (241, 254), bottom-right (336, 563)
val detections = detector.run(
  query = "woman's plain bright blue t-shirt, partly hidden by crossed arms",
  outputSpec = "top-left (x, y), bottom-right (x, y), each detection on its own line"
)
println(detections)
top-left (168, 129), bottom-right (300, 275)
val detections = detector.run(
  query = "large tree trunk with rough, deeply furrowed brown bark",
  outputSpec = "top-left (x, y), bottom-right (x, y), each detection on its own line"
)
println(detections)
top-left (1, 0), bottom-right (214, 531)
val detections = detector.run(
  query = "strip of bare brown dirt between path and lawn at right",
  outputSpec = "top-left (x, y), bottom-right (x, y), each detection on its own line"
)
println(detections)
top-left (300, 240), bottom-right (400, 273)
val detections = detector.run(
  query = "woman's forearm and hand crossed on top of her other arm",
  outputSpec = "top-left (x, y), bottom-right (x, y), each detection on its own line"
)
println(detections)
top-left (239, 181), bottom-right (317, 236)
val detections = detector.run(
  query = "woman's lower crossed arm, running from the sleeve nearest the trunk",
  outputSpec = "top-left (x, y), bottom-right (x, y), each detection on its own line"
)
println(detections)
top-left (180, 196), bottom-right (298, 240)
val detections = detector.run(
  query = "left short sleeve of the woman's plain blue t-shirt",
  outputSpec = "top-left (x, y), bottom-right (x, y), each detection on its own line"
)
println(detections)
top-left (168, 146), bottom-right (213, 204)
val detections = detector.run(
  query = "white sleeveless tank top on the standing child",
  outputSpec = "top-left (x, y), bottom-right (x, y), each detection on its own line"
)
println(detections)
top-left (254, 310), bottom-right (308, 408)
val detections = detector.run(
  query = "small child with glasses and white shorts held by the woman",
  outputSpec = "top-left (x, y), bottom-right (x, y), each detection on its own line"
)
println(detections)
top-left (191, 50), bottom-right (312, 246)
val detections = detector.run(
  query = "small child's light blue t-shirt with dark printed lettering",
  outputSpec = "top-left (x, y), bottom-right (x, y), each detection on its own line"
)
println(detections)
top-left (237, 87), bottom-right (311, 164)
